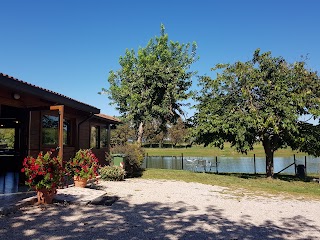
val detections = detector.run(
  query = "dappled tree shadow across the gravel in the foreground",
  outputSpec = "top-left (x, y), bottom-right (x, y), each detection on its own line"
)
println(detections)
top-left (0, 199), bottom-right (320, 240)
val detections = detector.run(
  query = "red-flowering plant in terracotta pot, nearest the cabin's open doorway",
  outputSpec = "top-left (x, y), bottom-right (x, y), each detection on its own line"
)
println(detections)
top-left (21, 151), bottom-right (65, 204)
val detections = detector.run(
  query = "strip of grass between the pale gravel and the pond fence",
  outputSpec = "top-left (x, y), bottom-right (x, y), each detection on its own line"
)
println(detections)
top-left (142, 169), bottom-right (320, 200)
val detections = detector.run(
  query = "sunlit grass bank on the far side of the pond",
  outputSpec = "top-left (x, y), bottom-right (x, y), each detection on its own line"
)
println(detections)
top-left (144, 143), bottom-right (307, 157)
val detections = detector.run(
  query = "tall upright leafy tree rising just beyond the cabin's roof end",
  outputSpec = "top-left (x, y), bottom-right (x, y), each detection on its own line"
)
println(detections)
top-left (103, 25), bottom-right (197, 143)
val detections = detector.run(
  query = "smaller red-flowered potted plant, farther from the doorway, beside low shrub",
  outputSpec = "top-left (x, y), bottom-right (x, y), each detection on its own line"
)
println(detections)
top-left (66, 149), bottom-right (99, 187)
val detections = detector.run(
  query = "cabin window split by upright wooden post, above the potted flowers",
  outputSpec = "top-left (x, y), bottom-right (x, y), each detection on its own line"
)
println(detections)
top-left (42, 115), bottom-right (71, 145)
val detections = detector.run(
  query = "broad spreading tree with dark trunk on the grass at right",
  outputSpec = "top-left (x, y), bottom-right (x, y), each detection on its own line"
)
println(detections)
top-left (194, 49), bottom-right (320, 177)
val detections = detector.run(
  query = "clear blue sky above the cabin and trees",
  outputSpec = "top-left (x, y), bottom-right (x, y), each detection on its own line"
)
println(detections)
top-left (0, 0), bottom-right (320, 119)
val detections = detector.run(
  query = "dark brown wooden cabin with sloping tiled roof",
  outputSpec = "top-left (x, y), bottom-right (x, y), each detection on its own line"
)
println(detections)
top-left (0, 73), bottom-right (120, 193)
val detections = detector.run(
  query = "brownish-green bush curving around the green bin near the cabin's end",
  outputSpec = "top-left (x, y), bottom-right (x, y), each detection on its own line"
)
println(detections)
top-left (108, 144), bottom-right (144, 177)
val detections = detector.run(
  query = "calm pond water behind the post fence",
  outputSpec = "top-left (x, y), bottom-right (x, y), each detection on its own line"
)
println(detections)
top-left (142, 156), bottom-right (320, 174)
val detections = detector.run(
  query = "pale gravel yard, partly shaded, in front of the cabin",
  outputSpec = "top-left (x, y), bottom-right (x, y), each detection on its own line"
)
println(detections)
top-left (0, 179), bottom-right (320, 240)
